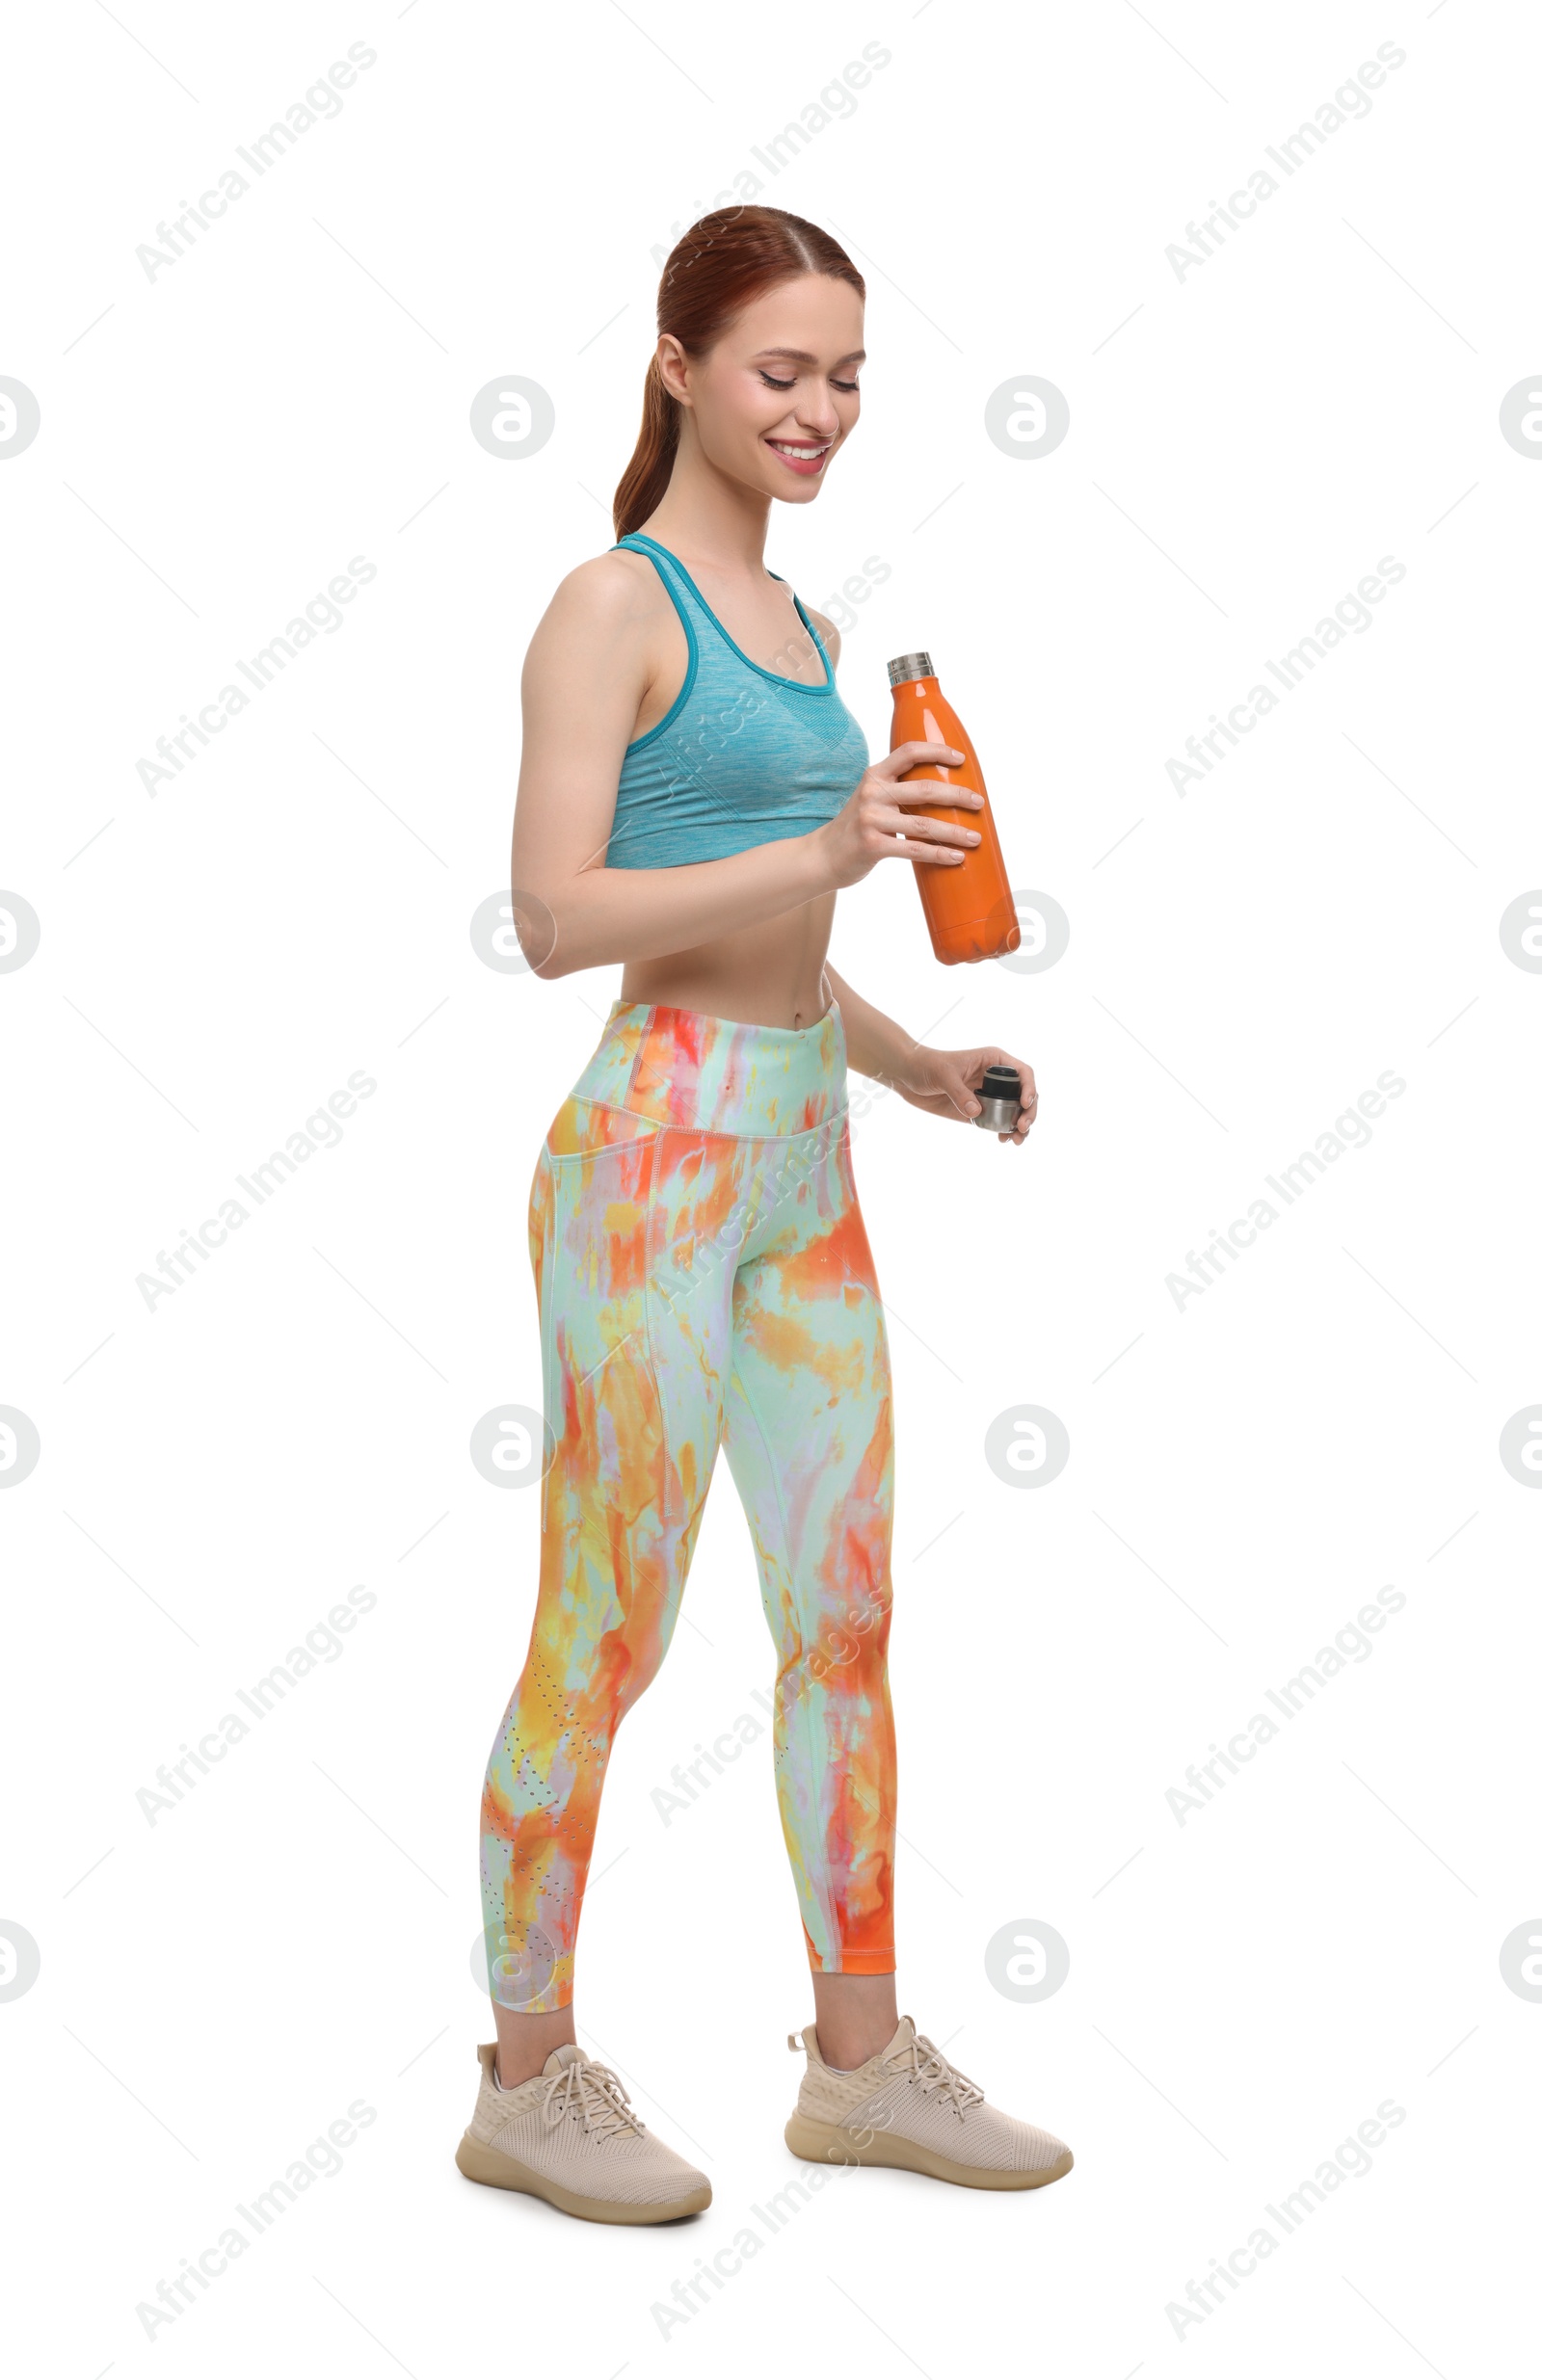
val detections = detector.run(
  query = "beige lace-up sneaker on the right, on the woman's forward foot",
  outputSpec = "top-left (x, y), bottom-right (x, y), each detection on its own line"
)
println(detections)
top-left (785, 2016), bottom-right (1071, 2189)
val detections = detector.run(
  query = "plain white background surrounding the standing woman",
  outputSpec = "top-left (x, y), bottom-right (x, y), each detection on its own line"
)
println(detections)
top-left (0, 0), bottom-right (1542, 2380)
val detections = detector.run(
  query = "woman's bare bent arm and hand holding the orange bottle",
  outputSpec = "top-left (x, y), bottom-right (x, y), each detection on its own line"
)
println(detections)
top-left (512, 555), bottom-right (978, 976)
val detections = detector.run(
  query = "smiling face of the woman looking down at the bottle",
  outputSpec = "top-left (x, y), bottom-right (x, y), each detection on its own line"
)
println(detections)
top-left (659, 274), bottom-right (864, 505)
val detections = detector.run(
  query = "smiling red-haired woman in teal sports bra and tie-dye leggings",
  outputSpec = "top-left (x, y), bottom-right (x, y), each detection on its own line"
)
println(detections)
top-left (457, 207), bottom-right (1071, 2223)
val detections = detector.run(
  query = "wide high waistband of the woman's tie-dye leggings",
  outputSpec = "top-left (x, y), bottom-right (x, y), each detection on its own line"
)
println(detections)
top-left (573, 999), bottom-right (847, 1138)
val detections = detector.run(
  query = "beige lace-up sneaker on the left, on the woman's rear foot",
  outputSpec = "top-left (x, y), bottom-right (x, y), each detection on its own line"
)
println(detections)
top-left (455, 2042), bottom-right (711, 2223)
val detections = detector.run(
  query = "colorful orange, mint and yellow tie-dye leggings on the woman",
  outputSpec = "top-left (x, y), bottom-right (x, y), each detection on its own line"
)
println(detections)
top-left (481, 1002), bottom-right (894, 2011)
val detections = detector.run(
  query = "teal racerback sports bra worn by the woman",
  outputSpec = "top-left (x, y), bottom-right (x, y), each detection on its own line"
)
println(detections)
top-left (604, 531), bottom-right (868, 869)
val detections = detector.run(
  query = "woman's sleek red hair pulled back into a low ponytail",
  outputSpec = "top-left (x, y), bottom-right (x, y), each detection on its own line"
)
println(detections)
top-left (612, 207), bottom-right (866, 538)
